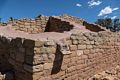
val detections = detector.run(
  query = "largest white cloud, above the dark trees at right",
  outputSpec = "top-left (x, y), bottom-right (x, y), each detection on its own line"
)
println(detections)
top-left (98, 6), bottom-right (119, 16)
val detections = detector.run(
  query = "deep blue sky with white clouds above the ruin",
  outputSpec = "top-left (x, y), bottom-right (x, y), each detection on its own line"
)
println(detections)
top-left (0, 0), bottom-right (120, 22)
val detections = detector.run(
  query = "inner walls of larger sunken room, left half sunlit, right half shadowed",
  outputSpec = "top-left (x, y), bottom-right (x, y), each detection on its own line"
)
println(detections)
top-left (9, 16), bottom-right (77, 34)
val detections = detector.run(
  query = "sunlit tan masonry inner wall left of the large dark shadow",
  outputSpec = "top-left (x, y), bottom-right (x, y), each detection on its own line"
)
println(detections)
top-left (8, 16), bottom-right (49, 34)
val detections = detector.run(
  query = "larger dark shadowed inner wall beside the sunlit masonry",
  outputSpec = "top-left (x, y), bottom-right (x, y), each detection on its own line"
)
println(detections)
top-left (45, 17), bottom-right (73, 33)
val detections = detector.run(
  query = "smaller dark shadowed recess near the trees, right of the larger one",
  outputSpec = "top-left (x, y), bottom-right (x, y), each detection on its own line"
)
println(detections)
top-left (83, 21), bottom-right (105, 32)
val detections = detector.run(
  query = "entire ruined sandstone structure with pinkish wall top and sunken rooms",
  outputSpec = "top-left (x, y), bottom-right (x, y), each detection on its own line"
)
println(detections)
top-left (0, 15), bottom-right (120, 80)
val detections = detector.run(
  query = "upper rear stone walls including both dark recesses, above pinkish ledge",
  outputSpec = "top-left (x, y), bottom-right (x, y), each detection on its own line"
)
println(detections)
top-left (8, 15), bottom-right (106, 34)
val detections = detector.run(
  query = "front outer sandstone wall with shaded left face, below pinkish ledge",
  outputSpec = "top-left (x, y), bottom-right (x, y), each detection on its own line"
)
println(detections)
top-left (0, 32), bottom-right (120, 80)
